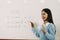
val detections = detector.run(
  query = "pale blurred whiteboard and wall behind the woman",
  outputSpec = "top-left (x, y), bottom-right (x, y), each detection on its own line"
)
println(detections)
top-left (0, 0), bottom-right (60, 40)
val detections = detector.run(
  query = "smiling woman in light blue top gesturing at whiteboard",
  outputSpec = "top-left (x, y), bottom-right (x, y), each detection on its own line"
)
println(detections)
top-left (30, 8), bottom-right (56, 40)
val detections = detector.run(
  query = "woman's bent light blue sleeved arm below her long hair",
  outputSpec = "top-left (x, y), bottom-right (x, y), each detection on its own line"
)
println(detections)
top-left (45, 24), bottom-right (55, 40)
